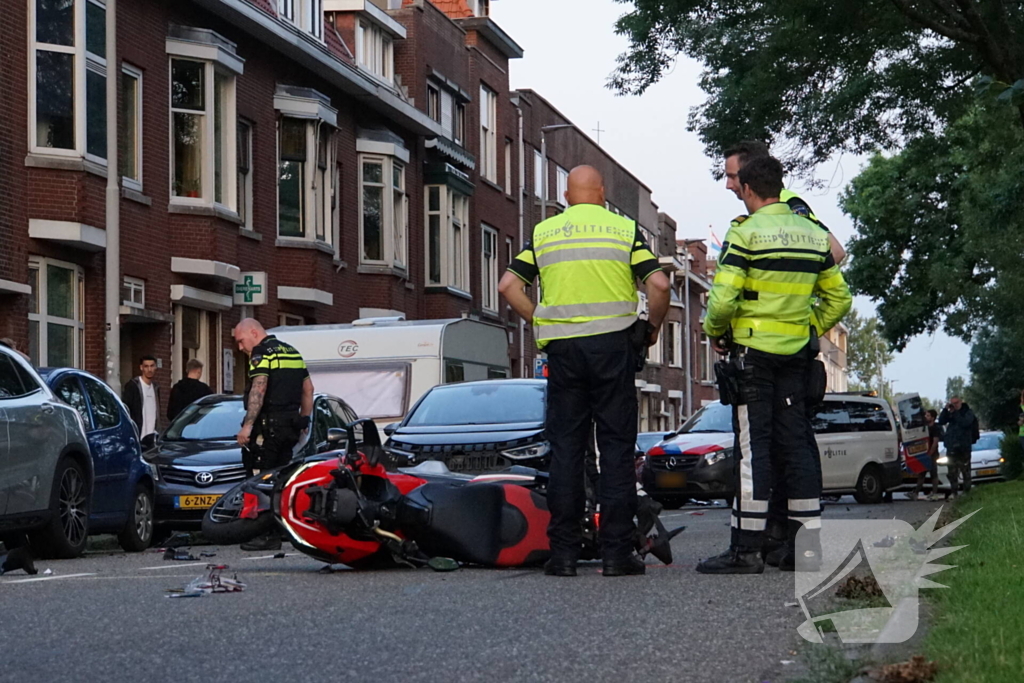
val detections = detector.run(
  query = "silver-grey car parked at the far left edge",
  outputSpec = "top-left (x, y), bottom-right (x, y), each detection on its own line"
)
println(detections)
top-left (0, 344), bottom-right (93, 557)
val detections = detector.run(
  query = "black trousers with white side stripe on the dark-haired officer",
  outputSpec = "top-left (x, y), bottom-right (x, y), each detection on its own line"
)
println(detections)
top-left (732, 346), bottom-right (821, 552)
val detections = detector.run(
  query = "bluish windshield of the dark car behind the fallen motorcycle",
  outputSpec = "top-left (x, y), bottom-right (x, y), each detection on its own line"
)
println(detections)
top-left (406, 382), bottom-right (545, 427)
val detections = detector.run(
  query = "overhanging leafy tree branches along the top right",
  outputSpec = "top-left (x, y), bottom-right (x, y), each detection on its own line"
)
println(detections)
top-left (609, 0), bottom-right (1024, 179)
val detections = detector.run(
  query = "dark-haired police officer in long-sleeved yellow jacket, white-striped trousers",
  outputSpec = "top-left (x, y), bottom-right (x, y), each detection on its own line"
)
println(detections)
top-left (697, 156), bottom-right (853, 573)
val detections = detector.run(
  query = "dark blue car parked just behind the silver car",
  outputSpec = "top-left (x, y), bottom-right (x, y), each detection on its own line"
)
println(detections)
top-left (39, 368), bottom-right (156, 552)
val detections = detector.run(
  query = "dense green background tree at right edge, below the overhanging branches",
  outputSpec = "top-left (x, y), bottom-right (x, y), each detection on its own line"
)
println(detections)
top-left (840, 106), bottom-right (1024, 349)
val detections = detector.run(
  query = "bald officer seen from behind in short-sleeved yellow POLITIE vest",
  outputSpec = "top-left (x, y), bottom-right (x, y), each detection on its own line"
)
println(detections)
top-left (498, 166), bottom-right (670, 577)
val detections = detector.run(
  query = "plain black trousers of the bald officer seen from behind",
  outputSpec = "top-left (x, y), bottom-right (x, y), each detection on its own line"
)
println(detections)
top-left (545, 331), bottom-right (637, 562)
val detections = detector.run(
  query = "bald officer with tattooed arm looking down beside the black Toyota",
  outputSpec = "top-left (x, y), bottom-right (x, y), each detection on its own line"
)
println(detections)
top-left (233, 317), bottom-right (313, 551)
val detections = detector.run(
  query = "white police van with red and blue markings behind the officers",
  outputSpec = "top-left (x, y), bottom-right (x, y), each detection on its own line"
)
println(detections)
top-left (641, 392), bottom-right (927, 507)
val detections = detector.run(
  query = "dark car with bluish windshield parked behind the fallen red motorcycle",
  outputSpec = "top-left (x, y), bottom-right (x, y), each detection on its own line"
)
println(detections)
top-left (384, 379), bottom-right (550, 474)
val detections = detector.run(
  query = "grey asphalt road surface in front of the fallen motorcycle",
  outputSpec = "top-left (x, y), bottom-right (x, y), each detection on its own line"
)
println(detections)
top-left (0, 495), bottom-right (937, 683)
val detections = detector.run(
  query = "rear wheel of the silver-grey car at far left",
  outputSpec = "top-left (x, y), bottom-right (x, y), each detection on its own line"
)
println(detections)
top-left (30, 457), bottom-right (90, 559)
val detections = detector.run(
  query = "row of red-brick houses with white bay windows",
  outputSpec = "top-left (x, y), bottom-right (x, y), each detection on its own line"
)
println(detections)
top-left (0, 0), bottom-right (716, 429)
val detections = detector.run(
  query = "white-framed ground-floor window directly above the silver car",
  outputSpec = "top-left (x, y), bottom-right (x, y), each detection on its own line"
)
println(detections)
top-left (29, 257), bottom-right (85, 368)
